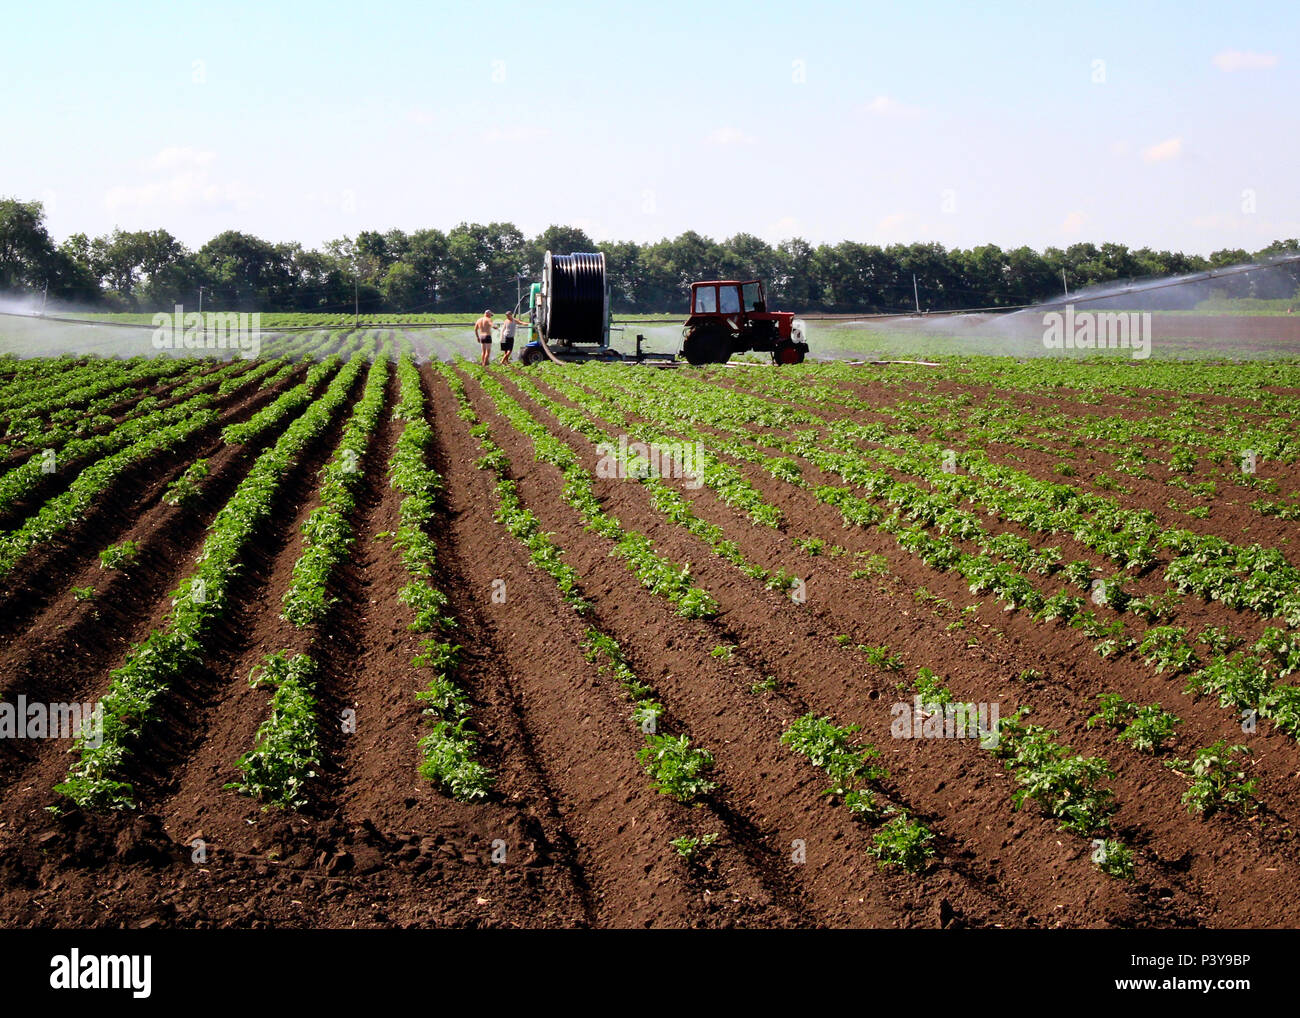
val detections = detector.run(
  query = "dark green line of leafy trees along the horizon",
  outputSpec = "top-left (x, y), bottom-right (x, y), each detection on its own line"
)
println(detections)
top-left (0, 199), bottom-right (1300, 313)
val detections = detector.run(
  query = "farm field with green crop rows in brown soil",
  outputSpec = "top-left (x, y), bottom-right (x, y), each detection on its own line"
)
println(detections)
top-left (0, 330), bottom-right (1300, 928)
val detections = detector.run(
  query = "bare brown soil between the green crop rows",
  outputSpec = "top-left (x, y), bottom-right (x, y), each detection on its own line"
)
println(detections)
top-left (0, 353), bottom-right (1300, 928)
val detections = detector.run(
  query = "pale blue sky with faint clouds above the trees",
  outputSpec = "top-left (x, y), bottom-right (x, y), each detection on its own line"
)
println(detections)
top-left (0, 0), bottom-right (1300, 254)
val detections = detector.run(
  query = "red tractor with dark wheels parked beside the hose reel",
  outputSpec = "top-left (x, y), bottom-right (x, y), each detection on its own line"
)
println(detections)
top-left (681, 280), bottom-right (809, 364)
